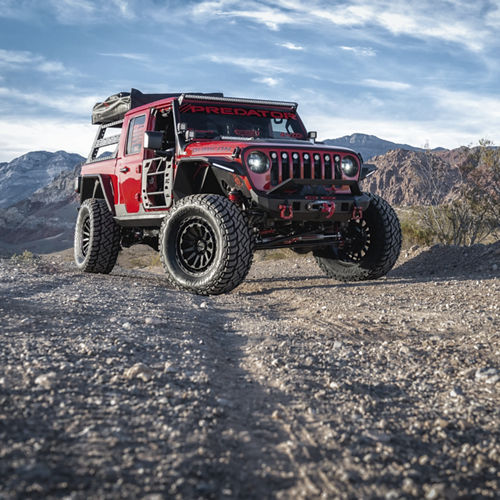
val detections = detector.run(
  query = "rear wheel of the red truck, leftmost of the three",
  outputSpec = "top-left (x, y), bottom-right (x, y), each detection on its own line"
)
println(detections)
top-left (74, 198), bottom-right (120, 274)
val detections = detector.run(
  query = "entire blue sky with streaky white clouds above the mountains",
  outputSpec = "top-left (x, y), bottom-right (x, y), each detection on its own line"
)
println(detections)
top-left (0, 0), bottom-right (500, 161)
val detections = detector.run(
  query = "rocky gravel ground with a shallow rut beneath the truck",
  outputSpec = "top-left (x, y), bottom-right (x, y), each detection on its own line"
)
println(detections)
top-left (0, 244), bottom-right (500, 500)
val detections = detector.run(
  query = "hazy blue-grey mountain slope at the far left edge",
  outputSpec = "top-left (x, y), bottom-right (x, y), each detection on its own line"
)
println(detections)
top-left (0, 151), bottom-right (84, 208)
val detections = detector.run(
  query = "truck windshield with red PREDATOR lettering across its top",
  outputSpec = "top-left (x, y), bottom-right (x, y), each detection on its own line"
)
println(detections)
top-left (180, 103), bottom-right (307, 139)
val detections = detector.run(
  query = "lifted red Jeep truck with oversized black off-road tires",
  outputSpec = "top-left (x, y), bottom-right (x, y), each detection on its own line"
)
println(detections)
top-left (75, 89), bottom-right (401, 295)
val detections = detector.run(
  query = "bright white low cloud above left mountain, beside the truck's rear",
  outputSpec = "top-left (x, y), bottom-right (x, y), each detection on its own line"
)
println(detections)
top-left (0, 116), bottom-right (95, 162)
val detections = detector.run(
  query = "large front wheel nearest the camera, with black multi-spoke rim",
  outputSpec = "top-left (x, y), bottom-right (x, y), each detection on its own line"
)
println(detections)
top-left (159, 194), bottom-right (253, 295)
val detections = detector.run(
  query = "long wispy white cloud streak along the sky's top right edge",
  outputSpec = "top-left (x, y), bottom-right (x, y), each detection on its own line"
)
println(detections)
top-left (188, 0), bottom-right (492, 52)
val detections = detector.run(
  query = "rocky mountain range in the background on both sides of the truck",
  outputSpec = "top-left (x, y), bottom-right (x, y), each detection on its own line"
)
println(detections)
top-left (0, 134), bottom-right (468, 254)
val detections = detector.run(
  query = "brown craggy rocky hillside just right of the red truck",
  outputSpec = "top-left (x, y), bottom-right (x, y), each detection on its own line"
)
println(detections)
top-left (363, 148), bottom-right (462, 206)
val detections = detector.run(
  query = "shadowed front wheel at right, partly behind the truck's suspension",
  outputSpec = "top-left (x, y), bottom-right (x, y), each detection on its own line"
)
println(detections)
top-left (313, 194), bottom-right (401, 281)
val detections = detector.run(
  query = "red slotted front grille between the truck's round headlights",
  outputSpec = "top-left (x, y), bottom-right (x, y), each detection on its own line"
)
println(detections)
top-left (269, 150), bottom-right (342, 186)
